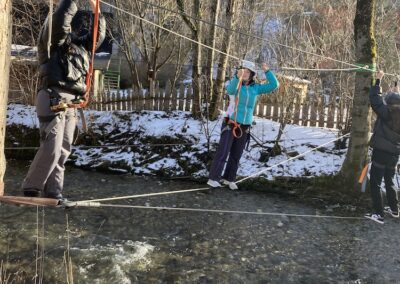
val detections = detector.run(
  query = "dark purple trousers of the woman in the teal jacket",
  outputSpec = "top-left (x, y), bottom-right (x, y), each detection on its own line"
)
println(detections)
top-left (209, 120), bottom-right (250, 181)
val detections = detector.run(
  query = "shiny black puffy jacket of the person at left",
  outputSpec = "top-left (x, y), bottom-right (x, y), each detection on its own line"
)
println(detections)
top-left (38, 0), bottom-right (106, 95)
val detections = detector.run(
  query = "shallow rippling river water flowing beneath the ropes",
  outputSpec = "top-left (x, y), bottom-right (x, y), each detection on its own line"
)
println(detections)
top-left (0, 161), bottom-right (400, 283)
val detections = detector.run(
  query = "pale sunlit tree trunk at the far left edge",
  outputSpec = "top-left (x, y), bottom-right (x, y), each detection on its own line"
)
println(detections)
top-left (0, 0), bottom-right (11, 196)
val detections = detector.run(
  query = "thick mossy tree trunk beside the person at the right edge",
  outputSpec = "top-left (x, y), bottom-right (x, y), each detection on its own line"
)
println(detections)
top-left (339, 0), bottom-right (376, 189)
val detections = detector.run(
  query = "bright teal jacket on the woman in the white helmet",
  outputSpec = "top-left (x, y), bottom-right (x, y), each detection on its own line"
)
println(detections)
top-left (226, 70), bottom-right (279, 125)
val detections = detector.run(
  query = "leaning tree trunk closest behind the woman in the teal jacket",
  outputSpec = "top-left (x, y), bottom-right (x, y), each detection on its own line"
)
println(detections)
top-left (210, 0), bottom-right (237, 119)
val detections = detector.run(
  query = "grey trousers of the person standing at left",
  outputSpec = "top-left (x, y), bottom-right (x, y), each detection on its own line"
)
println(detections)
top-left (22, 90), bottom-right (77, 197)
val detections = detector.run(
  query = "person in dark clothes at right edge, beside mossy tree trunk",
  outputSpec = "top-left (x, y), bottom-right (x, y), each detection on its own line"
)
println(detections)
top-left (365, 71), bottom-right (400, 224)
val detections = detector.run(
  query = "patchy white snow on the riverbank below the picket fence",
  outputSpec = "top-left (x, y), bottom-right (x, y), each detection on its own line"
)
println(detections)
top-left (7, 104), bottom-right (346, 179)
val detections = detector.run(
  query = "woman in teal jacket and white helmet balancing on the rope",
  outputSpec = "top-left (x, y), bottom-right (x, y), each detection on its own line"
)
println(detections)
top-left (207, 60), bottom-right (279, 190)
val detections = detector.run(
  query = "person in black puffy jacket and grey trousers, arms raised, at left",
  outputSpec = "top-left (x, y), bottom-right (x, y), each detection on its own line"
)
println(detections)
top-left (22, 0), bottom-right (106, 200)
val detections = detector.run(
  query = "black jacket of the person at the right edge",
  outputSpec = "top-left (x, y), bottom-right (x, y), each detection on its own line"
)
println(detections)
top-left (369, 86), bottom-right (400, 155)
